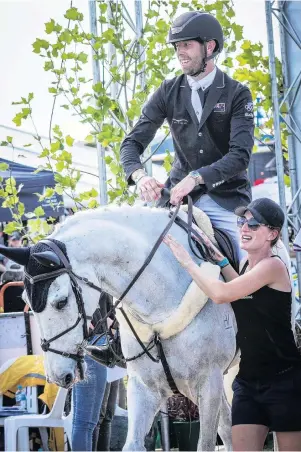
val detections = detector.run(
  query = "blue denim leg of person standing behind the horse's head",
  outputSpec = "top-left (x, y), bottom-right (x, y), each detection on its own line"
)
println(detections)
top-left (72, 356), bottom-right (107, 451)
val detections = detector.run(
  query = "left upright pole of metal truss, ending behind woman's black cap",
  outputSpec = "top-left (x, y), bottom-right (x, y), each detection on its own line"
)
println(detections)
top-left (265, 0), bottom-right (289, 251)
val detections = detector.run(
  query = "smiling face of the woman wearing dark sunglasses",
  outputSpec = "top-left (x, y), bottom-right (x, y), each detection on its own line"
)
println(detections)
top-left (239, 212), bottom-right (278, 252)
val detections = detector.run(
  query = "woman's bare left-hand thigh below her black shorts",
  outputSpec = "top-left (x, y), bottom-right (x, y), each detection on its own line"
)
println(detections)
top-left (232, 424), bottom-right (268, 452)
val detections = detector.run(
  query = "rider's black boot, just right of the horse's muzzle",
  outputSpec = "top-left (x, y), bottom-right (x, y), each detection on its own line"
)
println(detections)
top-left (85, 333), bottom-right (126, 368)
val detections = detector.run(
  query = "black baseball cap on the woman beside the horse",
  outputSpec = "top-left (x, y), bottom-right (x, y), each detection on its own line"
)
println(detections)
top-left (234, 198), bottom-right (285, 229)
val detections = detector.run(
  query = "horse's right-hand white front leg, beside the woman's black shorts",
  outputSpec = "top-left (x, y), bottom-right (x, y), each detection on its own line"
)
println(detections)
top-left (198, 367), bottom-right (223, 451)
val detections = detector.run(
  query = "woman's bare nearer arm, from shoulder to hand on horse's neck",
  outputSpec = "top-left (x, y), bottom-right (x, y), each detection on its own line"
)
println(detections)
top-left (164, 235), bottom-right (284, 304)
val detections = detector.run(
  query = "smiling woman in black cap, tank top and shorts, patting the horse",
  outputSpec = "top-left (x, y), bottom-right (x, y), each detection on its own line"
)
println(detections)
top-left (164, 198), bottom-right (301, 451)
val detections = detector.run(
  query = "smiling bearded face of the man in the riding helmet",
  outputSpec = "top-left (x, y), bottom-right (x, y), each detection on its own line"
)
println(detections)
top-left (175, 41), bottom-right (204, 75)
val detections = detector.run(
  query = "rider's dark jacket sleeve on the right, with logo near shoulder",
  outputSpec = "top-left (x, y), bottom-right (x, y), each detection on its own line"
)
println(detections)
top-left (198, 87), bottom-right (254, 191)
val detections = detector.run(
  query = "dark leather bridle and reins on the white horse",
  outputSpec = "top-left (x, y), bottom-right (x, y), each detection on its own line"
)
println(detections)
top-left (24, 197), bottom-right (212, 377)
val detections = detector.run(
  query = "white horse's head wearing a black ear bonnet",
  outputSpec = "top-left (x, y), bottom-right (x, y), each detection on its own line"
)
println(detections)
top-left (0, 240), bottom-right (97, 387)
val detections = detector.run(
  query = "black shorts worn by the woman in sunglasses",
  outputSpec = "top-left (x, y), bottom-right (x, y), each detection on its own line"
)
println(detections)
top-left (232, 368), bottom-right (301, 432)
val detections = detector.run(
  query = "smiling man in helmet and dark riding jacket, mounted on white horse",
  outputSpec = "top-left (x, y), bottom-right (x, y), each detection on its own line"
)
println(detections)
top-left (89, 11), bottom-right (254, 362)
